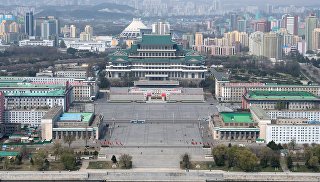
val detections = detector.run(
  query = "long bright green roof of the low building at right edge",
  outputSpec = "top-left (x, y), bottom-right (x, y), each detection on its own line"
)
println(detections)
top-left (248, 91), bottom-right (319, 100)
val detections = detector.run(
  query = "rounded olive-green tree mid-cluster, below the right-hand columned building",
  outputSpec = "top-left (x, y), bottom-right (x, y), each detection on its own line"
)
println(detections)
top-left (236, 148), bottom-right (258, 171)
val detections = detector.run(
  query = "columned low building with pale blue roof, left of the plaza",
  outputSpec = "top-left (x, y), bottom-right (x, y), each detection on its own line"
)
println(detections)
top-left (41, 107), bottom-right (104, 140)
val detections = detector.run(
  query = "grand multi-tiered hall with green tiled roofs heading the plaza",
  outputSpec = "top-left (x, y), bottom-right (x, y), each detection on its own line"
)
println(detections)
top-left (106, 35), bottom-right (207, 80)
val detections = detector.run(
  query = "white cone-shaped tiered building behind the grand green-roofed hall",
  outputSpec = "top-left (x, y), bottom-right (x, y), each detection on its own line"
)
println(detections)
top-left (120, 18), bottom-right (148, 38)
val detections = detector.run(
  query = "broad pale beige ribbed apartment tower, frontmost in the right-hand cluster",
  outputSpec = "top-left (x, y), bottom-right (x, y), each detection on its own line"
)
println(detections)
top-left (263, 32), bottom-right (283, 59)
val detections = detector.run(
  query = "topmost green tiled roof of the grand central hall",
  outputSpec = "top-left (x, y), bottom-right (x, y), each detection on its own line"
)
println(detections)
top-left (138, 35), bottom-right (176, 45)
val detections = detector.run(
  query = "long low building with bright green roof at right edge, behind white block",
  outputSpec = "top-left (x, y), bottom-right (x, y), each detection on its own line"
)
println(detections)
top-left (243, 91), bottom-right (320, 110)
